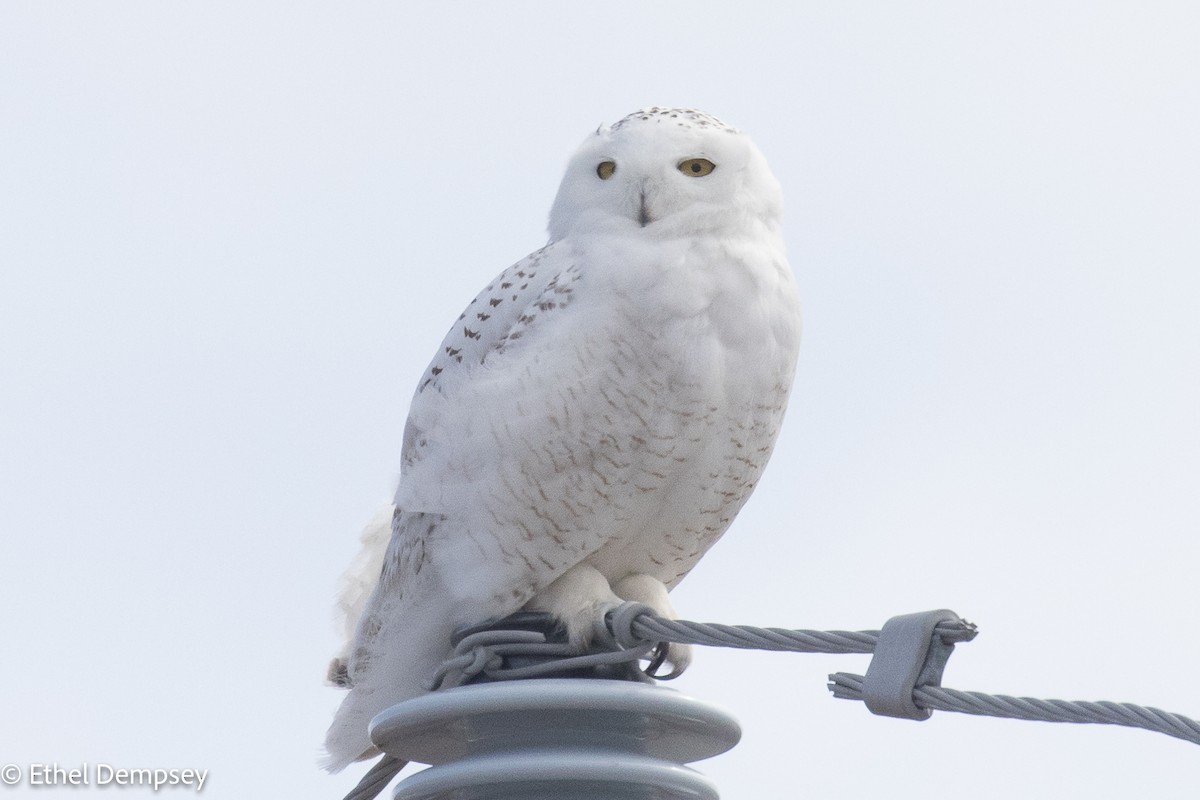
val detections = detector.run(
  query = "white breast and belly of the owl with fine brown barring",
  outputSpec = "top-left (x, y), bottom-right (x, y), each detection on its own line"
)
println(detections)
top-left (501, 231), bottom-right (799, 587)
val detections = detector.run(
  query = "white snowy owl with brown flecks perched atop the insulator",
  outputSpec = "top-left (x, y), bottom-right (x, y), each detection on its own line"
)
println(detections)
top-left (325, 108), bottom-right (800, 770)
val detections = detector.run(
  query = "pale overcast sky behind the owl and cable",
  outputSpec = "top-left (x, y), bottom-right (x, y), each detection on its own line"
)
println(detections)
top-left (0, 1), bottom-right (1200, 800)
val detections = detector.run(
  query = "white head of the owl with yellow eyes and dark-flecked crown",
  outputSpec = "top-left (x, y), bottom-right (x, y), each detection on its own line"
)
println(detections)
top-left (550, 108), bottom-right (781, 241)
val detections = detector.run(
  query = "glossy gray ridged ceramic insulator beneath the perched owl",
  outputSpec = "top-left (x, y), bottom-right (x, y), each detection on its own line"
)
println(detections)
top-left (371, 679), bottom-right (742, 800)
